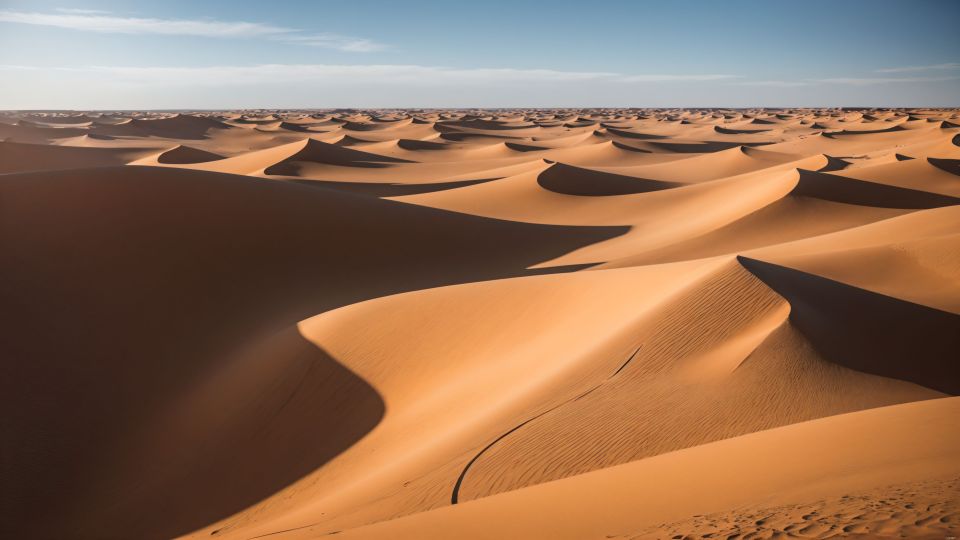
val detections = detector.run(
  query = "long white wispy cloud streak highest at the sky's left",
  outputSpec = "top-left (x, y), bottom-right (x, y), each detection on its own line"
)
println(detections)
top-left (0, 8), bottom-right (387, 52)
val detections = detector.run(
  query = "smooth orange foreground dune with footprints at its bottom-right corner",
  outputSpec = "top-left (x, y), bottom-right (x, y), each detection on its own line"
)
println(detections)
top-left (332, 398), bottom-right (960, 538)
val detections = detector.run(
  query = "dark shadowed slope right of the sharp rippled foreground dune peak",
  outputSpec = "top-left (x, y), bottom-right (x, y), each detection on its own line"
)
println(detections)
top-left (737, 256), bottom-right (960, 395)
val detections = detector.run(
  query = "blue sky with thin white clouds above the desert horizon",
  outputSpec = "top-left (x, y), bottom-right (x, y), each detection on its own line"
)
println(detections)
top-left (0, 0), bottom-right (960, 110)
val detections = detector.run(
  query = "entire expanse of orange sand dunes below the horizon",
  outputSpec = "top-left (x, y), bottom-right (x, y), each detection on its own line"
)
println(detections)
top-left (0, 109), bottom-right (960, 539)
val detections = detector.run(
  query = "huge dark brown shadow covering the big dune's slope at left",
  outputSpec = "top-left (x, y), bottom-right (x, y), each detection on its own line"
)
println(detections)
top-left (0, 166), bottom-right (628, 538)
